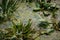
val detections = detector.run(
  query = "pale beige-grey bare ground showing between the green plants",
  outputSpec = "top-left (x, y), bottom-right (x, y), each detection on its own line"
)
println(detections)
top-left (0, 0), bottom-right (60, 40)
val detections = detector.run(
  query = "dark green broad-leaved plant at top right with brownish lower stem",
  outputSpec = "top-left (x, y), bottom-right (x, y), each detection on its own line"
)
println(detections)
top-left (33, 0), bottom-right (59, 29)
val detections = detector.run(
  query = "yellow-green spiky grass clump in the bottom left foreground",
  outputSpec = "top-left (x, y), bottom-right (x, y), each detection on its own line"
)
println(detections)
top-left (0, 20), bottom-right (37, 40)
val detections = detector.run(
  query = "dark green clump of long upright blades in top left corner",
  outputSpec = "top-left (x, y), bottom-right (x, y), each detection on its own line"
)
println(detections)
top-left (0, 0), bottom-right (20, 23)
